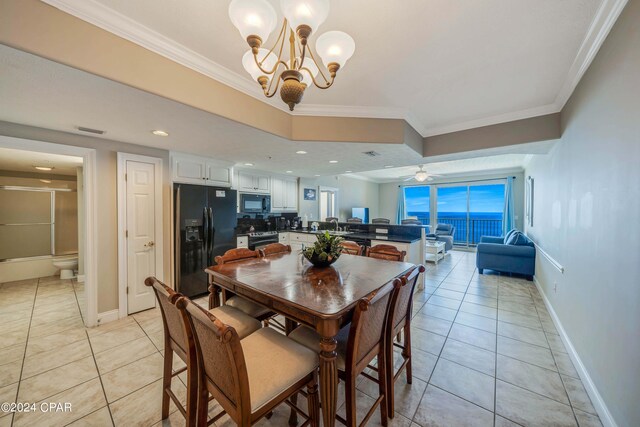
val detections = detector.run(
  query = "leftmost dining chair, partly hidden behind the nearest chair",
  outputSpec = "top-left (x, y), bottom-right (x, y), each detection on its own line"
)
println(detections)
top-left (144, 277), bottom-right (261, 426)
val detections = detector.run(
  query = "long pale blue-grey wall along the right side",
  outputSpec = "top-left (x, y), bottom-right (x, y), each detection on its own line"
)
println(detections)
top-left (525, 0), bottom-right (640, 427)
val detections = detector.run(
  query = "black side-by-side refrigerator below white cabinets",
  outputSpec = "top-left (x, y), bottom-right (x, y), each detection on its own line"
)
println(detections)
top-left (173, 184), bottom-right (238, 297)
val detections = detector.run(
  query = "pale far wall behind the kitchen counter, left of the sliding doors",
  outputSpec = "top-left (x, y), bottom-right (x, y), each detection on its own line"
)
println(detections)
top-left (298, 176), bottom-right (380, 221)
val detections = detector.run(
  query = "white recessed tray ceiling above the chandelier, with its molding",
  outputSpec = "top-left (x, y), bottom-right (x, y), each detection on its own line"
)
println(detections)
top-left (44, 0), bottom-right (626, 135)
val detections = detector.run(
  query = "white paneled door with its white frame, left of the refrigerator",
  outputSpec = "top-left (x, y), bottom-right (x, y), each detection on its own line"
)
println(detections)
top-left (118, 153), bottom-right (164, 317)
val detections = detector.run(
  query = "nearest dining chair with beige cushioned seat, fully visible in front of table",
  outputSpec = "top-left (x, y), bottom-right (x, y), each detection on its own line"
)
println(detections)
top-left (176, 298), bottom-right (320, 426)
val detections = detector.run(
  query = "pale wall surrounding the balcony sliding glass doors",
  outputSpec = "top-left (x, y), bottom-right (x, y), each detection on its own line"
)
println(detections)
top-left (380, 172), bottom-right (524, 230)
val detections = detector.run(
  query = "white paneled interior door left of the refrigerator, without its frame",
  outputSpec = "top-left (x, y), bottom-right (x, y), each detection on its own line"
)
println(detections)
top-left (126, 160), bottom-right (158, 314)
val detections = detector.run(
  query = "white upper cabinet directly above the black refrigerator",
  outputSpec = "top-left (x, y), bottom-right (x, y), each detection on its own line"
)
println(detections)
top-left (171, 153), bottom-right (233, 187)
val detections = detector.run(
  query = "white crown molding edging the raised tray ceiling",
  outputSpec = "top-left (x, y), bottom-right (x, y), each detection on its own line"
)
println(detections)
top-left (41, 0), bottom-right (628, 137)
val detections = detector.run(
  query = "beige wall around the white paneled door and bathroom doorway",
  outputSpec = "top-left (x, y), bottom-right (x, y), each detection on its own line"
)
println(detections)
top-left (0, 122), bottom-right (171, 313)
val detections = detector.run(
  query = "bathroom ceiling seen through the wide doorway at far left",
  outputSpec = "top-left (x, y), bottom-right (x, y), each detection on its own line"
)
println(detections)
top-left (0, 148), bottom-right (82, 176)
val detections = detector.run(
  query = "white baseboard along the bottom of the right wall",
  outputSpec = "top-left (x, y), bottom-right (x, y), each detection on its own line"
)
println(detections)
top-left (533, 276), bottom-right (618, 427)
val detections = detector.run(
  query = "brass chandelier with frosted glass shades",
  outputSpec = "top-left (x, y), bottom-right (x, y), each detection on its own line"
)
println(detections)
top-left (229, 0), bottom-right (356, 111)
